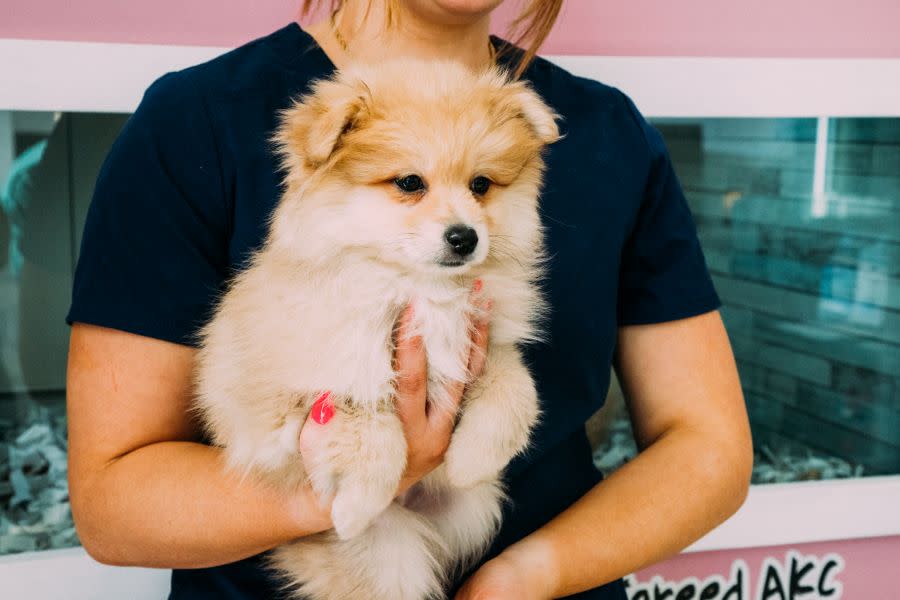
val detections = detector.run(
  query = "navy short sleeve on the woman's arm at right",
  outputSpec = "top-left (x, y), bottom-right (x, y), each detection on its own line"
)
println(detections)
top-left (617, 93), bottom-right (721, 325)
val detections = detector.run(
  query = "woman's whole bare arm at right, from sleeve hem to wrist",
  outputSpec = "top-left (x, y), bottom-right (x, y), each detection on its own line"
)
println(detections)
top-left (458, 312), bottom-right (753, 599)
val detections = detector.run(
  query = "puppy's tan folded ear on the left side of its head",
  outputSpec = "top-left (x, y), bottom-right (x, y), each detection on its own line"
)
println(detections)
top-left (275, 79), bottom-right (371, 171)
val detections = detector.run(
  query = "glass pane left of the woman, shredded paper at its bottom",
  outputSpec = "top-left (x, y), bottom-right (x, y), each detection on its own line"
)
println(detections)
top-left (0, 111), bottom-right (126, 554)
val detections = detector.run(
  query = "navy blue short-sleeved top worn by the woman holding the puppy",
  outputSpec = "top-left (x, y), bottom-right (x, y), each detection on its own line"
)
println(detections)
top-left (67, 24), bottom-right (719, 600)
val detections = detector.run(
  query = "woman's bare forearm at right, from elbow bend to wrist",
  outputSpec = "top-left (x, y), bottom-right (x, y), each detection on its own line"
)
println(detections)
top-left (504, 429), bottom-right (752, 598)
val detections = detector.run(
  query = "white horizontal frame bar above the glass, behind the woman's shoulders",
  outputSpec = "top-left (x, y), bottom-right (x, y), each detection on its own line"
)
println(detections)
top-left (0, 38), bottom-right (900, 117)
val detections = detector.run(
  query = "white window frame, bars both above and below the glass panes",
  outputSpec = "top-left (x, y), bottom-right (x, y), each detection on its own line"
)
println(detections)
top-left (0, 39), bottom-right (900, 598)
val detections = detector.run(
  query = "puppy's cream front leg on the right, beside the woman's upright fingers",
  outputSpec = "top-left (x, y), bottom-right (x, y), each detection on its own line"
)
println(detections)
top-left (444, 346), bottom-right (539, 487)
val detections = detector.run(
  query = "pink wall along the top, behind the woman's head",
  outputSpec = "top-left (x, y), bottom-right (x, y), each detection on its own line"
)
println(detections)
top-left (0, 0), bottom-right (900, 58)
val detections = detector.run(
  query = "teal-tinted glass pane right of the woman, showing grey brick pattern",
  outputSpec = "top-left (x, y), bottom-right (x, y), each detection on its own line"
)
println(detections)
top-left (591, 118), bottom-right (900, 483)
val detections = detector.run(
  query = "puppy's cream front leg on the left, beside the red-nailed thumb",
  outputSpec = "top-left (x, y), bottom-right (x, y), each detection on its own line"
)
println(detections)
top-left (305, 402), bottom-right (406, 539)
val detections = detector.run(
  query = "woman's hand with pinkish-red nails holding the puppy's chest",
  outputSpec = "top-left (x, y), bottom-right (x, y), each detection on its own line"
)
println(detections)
top-left (300, 285), bottom-right (489, 508)
